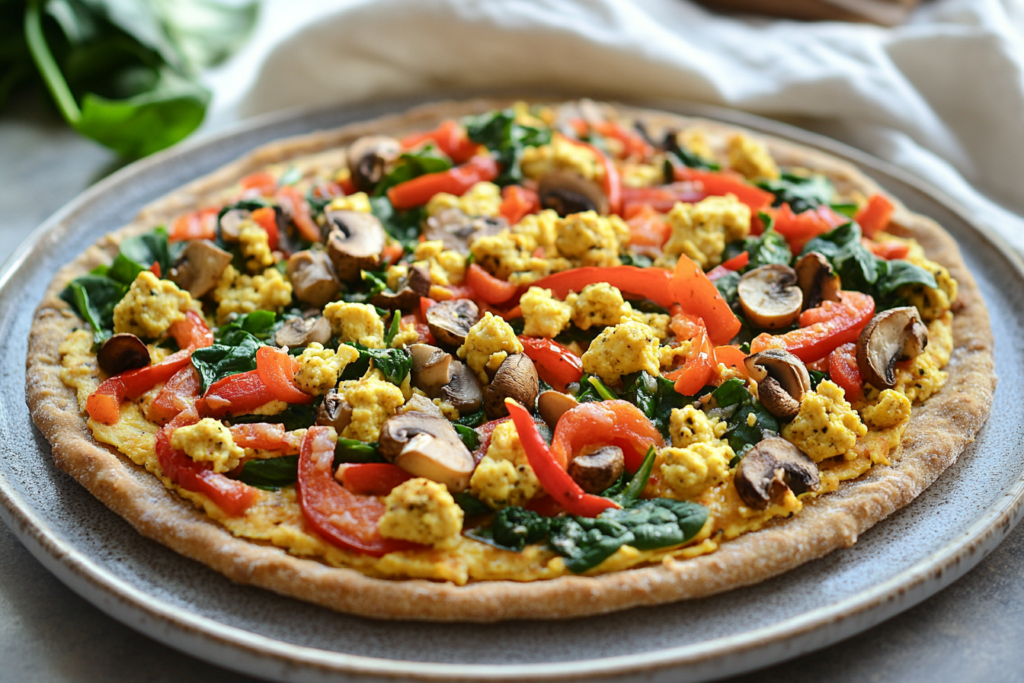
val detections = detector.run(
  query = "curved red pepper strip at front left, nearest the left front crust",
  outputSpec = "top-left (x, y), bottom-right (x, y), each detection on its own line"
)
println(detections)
top-left (156, 409), bottom-right (259, 517)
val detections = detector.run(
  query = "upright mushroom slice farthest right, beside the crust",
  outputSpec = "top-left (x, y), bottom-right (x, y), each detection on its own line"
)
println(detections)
top-left (857, 306), bottom-right (928, 389)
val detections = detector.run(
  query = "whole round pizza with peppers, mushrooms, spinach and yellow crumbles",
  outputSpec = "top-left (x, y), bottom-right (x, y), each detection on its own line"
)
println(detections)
top-left (27, 100), bottom-right (995, 621)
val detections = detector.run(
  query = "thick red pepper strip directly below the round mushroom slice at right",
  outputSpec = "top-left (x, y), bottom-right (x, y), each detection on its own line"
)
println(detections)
top-left (751, 291), bottom-right (874, 364)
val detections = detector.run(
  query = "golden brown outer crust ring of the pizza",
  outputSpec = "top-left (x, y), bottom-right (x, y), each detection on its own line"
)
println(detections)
top-left (26, 100), bottom-right (996, 622)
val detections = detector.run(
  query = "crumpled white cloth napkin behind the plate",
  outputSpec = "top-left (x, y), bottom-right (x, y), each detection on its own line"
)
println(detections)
top-left (201, 0), bottom-right (1024, 251)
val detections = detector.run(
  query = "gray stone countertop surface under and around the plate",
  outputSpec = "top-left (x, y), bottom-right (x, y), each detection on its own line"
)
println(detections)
top-left (0, 94), bottom-right (1024, 683)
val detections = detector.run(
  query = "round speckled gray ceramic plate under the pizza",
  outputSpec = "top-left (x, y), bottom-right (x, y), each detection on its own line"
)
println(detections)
top-left (0, 100), bottom-right (1024, 681)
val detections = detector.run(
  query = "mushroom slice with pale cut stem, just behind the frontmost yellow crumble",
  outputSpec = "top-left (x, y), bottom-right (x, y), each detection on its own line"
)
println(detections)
top-left (378, 411), bottom-right (476, 494)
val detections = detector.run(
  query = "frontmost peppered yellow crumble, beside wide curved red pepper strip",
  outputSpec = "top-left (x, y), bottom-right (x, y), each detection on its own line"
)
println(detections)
top-left (378, 478), bottom-right (464, 547)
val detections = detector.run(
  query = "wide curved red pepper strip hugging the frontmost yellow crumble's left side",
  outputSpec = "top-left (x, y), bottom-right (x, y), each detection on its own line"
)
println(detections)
top-left (296, 427), bottom-right (423, 557)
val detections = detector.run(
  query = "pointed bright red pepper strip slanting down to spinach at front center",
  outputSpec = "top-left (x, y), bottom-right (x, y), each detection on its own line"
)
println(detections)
top-left (505, 398), bottom-right (622, 517)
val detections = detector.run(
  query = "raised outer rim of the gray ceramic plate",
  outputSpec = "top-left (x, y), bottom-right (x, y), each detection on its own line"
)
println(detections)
top-left (0, 97), bottom-right (1024, 681)
